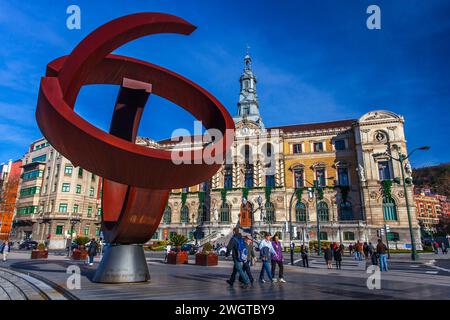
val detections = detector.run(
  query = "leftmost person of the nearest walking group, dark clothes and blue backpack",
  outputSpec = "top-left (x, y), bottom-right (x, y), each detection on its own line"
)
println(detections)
top-left (225, 228), bottom-right (250, 288)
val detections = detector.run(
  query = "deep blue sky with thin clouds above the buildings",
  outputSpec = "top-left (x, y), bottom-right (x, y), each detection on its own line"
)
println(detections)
top-left (0, 0), bottom-right (450, 166)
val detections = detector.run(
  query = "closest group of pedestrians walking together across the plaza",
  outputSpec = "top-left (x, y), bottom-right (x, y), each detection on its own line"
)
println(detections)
top-left (225, 228), bottom-right (286, 288)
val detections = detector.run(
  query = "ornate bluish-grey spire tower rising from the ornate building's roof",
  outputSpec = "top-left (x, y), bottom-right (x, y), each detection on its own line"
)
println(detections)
top-left (233, 47), bottom-right (264, 129)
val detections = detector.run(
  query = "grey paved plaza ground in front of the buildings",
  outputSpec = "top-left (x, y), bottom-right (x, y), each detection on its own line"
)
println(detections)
top-left (0, 252), bottom-right (450, 301)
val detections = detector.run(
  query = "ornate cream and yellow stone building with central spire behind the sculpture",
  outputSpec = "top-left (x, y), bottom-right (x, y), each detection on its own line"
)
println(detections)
top-left (152, 55), bottom-right (420, 248)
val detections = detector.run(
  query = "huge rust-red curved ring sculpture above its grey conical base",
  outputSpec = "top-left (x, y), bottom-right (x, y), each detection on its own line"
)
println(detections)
top-left (36, 13), bottom-right (234, 282)
